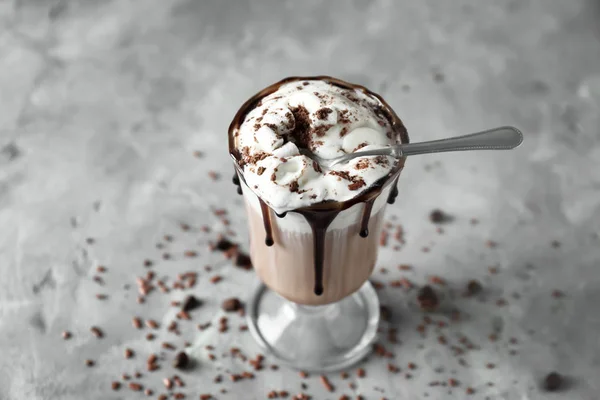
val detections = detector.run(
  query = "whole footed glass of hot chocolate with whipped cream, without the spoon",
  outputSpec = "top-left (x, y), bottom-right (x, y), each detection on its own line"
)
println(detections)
top-left (229, 76), bottom-right (408, 371)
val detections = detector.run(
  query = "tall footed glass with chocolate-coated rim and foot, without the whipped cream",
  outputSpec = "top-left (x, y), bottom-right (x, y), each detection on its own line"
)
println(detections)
top-left (229, 77), bottom-right (408, 371)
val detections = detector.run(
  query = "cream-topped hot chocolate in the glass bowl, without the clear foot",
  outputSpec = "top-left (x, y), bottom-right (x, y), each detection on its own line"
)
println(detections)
top-left (229, 76), bottom-right (408, 305)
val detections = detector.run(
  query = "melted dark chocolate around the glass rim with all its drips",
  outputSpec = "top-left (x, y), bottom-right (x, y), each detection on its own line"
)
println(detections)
top-left (228, 76), bottom-right (408, 296)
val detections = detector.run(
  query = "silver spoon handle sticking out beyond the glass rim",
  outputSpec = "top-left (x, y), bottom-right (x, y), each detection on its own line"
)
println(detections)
top-left (391, 126), bottom-right (523, 157)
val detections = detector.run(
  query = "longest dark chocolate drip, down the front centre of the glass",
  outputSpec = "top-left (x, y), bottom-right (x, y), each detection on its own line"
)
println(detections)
top-left (295, 209), bottom-right (340, 296)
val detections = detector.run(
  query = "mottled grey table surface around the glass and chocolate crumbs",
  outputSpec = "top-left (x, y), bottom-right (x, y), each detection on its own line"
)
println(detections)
top-left (0, 0), bottom-right (600, 400)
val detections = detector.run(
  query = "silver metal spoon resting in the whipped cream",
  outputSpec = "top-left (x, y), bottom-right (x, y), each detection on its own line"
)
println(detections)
top-left (300, 126), bottom-right (523, 169)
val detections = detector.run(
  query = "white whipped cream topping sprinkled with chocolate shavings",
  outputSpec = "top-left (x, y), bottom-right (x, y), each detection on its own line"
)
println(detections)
top-left (234, 80), bottom-right (396, 213)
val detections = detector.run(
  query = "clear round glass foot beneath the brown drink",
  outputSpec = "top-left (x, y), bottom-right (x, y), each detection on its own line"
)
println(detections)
top-left (247, 281), bottom-right (379, 372)
